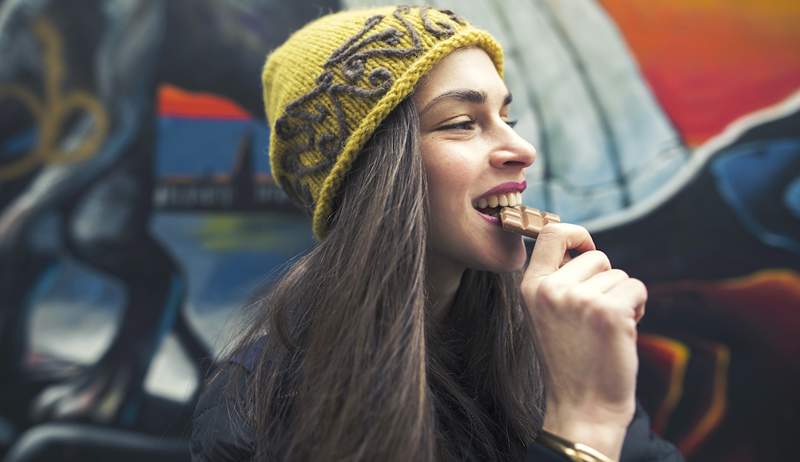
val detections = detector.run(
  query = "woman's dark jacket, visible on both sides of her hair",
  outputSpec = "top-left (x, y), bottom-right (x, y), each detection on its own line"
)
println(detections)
top-left (191, 344), bottom-right (683, 462)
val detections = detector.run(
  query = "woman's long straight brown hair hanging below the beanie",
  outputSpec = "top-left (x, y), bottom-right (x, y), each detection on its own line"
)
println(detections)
top-left (220, 98), bottom-right (544, 461)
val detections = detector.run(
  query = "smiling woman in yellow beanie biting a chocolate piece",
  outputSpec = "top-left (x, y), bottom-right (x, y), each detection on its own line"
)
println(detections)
top-left (193, 7), bottom-right (680, 461)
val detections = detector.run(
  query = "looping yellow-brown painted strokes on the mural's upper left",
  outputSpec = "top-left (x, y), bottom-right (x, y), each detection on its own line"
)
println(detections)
top-left (0, 18), bottom-right (109, 181)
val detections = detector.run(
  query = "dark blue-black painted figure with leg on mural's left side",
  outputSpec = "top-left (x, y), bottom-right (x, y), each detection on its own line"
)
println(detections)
top-left (0, 0), bottom-right (335, 436)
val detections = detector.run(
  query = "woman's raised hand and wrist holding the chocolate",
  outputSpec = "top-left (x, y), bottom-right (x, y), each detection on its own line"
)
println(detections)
top-left (521, 223), bottom-right (647, 459)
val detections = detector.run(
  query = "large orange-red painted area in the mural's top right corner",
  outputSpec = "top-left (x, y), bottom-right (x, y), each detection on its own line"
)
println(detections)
top-left (601, 0), bottom-right (800, 146)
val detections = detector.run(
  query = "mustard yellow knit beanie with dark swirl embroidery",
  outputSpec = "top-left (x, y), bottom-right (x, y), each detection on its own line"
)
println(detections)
top-left (262, 6), bottom-right (503, 240)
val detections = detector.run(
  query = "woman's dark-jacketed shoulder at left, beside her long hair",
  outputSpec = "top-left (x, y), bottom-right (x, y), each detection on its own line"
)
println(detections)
top-left (191, 342), bottom-right (263, 462)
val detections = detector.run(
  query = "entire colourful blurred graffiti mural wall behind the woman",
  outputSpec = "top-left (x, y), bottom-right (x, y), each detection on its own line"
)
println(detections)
top-left (0, 0), bottom-right (800, 461)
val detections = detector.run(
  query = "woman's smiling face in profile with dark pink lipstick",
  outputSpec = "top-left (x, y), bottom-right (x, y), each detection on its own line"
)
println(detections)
top-left (413, 47), bottom-right (536, 272)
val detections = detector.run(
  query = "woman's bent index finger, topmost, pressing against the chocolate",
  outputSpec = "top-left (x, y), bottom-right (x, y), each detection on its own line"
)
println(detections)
top-left (527, 223), bottom-right (595, 276)
